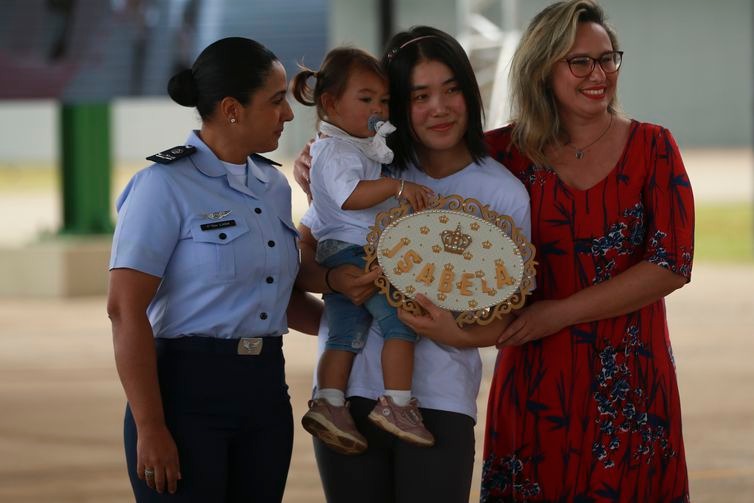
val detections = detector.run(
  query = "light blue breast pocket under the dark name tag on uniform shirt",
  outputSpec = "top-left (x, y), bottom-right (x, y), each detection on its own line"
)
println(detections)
top-left (191, 219), bottom-right (249, 282)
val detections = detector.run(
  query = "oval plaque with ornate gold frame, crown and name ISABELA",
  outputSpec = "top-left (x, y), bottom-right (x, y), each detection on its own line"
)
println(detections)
top-left (365, 195), bottom-right (535, 326)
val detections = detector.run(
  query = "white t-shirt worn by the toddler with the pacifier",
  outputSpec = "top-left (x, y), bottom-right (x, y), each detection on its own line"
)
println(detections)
top-left (310, 137), bottom-right (397, 245)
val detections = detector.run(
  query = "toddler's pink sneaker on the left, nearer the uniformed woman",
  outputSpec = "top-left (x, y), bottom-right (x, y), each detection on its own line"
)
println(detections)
top-left (301, 398), bottom-right (367, 454)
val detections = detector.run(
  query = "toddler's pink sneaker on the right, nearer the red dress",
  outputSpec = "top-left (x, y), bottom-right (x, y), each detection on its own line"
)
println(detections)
top-left (368, 395), bottom-right (435, 447)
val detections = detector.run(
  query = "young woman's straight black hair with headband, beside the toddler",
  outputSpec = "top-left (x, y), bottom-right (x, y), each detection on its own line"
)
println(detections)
top-left (382, 26), bottom-right (487, 169)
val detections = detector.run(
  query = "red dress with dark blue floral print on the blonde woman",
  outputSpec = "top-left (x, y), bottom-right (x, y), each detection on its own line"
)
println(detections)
top-left (481, 121), bottom-right (694, 503)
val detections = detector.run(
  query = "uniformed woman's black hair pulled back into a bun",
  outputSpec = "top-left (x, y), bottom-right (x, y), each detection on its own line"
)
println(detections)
top-left (168, 37), bottom-right (278, 120)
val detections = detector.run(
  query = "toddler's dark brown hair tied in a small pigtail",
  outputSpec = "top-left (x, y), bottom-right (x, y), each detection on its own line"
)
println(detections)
top-left (291, 47), bottom-right (385, 120)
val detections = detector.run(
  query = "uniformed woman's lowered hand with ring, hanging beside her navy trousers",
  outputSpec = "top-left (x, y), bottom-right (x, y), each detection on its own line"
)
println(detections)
top-left (136, 425), bottom-right (181, 494)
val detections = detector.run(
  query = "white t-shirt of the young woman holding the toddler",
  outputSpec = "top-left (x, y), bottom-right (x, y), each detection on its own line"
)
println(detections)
top-left (301, 157), bottom-right (531, 421)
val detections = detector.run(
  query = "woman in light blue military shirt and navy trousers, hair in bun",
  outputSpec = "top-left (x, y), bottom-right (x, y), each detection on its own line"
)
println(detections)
top-left (108, 38), bottom-right (319, 502)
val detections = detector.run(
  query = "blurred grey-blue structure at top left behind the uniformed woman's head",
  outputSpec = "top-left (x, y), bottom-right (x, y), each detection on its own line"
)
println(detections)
top-left (0, 0), bottom-right (327, 103)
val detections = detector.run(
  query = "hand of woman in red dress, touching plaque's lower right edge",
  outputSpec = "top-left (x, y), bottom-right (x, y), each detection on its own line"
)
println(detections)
top-left (496, 300), bottom-right (569, 349)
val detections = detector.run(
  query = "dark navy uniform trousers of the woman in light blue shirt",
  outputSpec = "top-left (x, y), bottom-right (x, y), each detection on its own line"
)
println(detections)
top-left (124, 337), bottom-right (293, 503)
